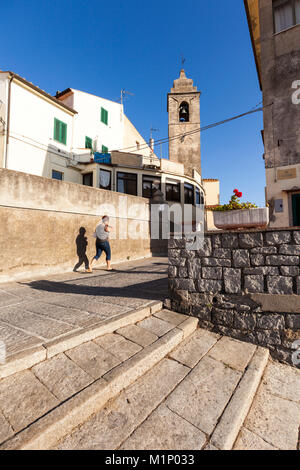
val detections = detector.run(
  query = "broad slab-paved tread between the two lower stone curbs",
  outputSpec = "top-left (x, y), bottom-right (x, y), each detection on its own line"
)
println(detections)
top-left (55, 329), bottom-right (269, 450)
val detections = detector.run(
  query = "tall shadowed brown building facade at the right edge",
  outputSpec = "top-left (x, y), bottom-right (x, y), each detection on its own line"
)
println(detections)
top-left (245, 0), bottom-right (300, 227)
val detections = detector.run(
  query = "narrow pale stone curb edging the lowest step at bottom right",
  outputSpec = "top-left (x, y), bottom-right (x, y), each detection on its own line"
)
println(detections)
top-left (210, 347), bottom-right (269, 450)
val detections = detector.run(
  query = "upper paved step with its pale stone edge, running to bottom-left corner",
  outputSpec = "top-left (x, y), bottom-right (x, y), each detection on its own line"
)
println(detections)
top-left (0, 303), bottom-right (198, 449)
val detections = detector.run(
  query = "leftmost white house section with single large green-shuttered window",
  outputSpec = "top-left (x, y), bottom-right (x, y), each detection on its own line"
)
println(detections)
top-left (0, 72), bottom-right (82, 183)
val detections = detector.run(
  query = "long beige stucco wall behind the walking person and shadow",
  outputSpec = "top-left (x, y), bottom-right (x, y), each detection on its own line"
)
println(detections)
top-left (0, 169), bottom-right (152, 282)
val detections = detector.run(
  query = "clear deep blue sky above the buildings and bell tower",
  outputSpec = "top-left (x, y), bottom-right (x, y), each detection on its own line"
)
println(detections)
top-left (0, 0), bottom-right (265, 205)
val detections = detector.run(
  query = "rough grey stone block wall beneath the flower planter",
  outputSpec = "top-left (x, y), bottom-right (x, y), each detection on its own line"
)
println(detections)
top-left (169, 230), bottom-right (300, 363)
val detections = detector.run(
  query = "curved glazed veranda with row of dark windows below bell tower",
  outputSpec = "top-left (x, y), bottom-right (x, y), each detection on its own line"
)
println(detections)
top-left (76, 151), bottom-right (205, 206)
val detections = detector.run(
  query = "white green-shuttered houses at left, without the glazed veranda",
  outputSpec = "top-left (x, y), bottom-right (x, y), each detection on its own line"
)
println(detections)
top-left (0, 72), bottom-right (155, 184)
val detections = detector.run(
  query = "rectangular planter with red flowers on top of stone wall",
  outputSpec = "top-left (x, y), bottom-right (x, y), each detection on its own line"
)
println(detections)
top-left (212, 189), bottom-right (269, 230)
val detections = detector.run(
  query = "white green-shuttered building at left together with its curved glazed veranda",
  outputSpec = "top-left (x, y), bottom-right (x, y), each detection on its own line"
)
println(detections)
top-left (0, 72), bottom-right (223, 227)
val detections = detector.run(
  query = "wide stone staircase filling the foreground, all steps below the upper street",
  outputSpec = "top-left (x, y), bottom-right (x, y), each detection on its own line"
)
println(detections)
top-left (0, 302), bottom-right (300, 450)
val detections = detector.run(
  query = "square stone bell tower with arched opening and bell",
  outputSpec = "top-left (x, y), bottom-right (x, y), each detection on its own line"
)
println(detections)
top-left (168, 69), bottom-right (201, 176)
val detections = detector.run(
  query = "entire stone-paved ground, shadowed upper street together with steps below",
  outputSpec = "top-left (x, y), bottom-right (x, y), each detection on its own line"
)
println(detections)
top-left (0, 258), bottom-right (300, 450)
